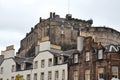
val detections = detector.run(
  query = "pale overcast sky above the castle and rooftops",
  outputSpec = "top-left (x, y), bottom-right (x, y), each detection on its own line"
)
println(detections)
top-left (0, 0), bottom-right (120, 52)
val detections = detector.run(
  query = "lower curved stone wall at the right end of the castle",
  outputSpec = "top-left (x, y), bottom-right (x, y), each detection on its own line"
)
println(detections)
top-left (81, 27), bottom-right (120, 46)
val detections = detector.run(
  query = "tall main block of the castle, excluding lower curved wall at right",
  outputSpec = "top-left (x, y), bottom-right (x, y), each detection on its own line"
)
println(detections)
top-left (18, 13), bottom-right (92, 57)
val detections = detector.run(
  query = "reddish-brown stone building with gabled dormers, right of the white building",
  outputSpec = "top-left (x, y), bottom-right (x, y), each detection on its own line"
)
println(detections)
top-left (68, 37), bottom-right (120, 80)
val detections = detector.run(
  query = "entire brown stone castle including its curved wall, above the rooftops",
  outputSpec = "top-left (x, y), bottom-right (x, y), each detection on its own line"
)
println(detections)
top-left (17, 13), bottom-right (120, 57)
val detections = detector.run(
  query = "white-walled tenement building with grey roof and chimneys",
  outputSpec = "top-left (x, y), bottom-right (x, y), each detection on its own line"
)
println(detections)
top-left (0, 38), bottom-right (71, 80)
